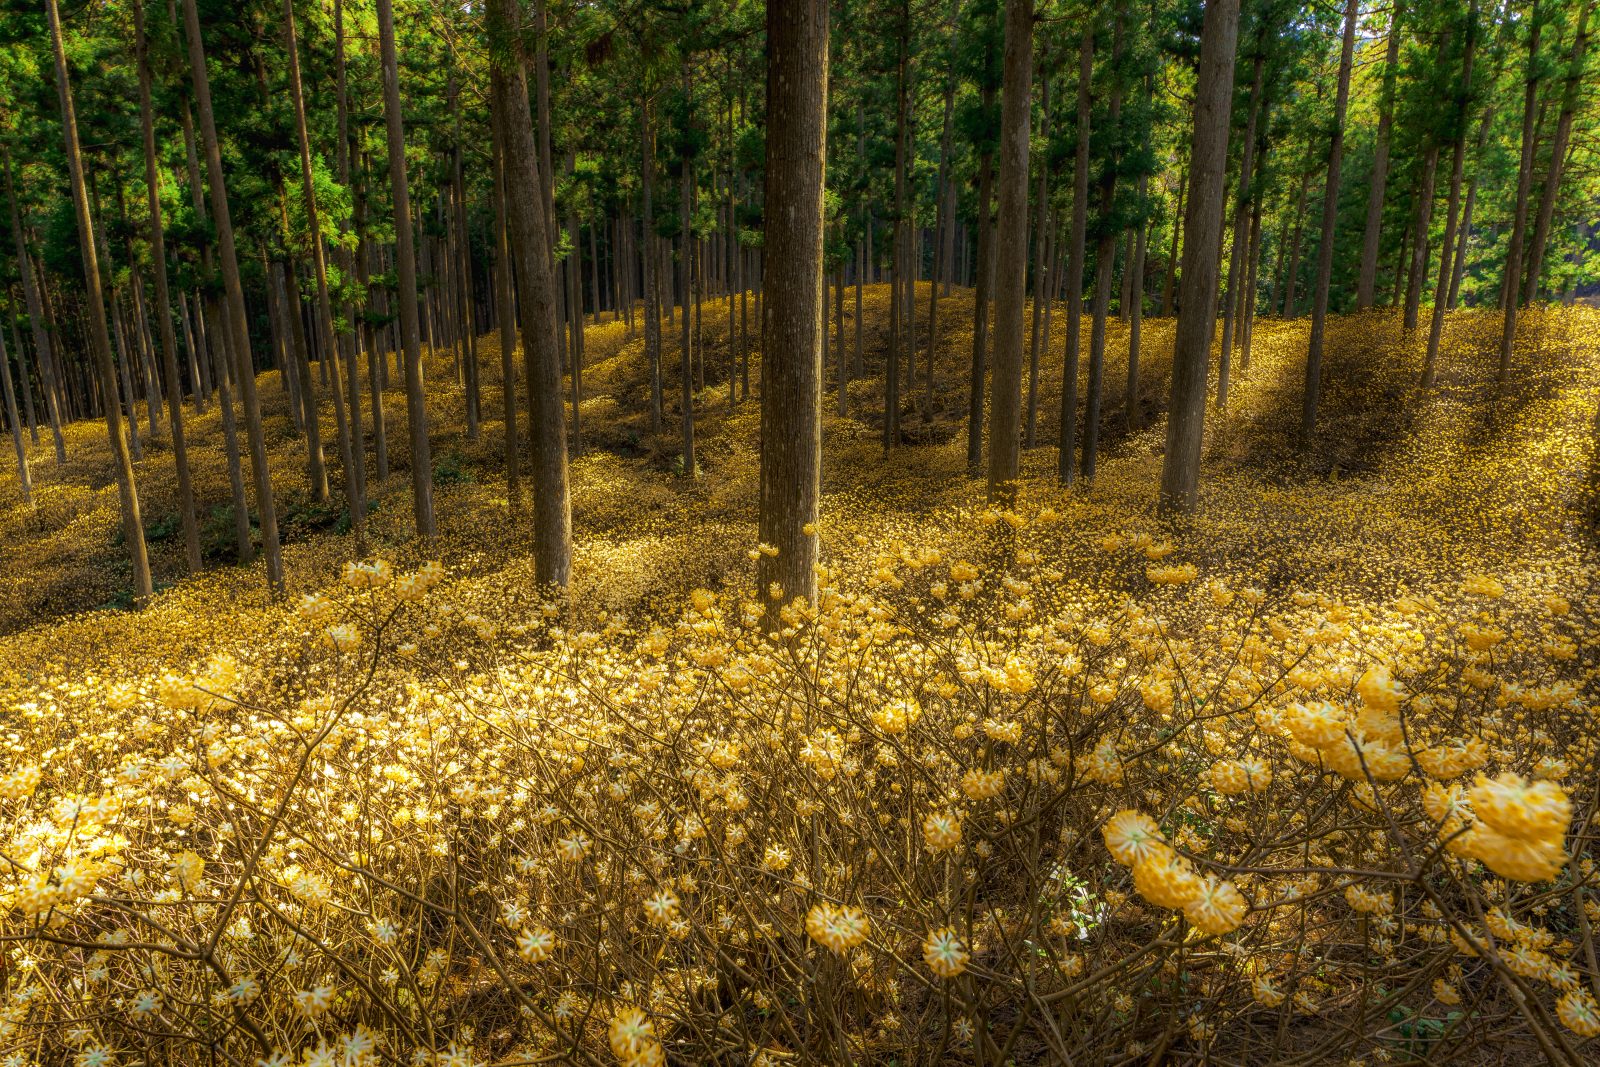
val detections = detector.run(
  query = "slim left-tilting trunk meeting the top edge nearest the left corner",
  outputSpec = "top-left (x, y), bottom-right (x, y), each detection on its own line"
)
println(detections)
top-left (45, 0), bottom-right (154, 605)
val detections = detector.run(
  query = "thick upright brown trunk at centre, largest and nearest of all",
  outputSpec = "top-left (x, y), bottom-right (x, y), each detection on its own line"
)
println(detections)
top-left (757, 0), bottom-right (829, 620)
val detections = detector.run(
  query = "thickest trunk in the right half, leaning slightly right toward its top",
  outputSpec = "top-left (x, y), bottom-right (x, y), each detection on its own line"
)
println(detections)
top-left (1162, 0), bottom-right (1238, 514)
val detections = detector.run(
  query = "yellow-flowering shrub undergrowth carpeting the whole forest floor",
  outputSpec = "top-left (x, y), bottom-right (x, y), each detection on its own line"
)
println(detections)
top-left (0, 286), bottom-right (1600, 1067)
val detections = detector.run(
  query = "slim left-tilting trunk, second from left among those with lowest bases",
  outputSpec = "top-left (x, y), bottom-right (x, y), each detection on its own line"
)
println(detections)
top-left (184, 0), bottom-right (283, 590)
